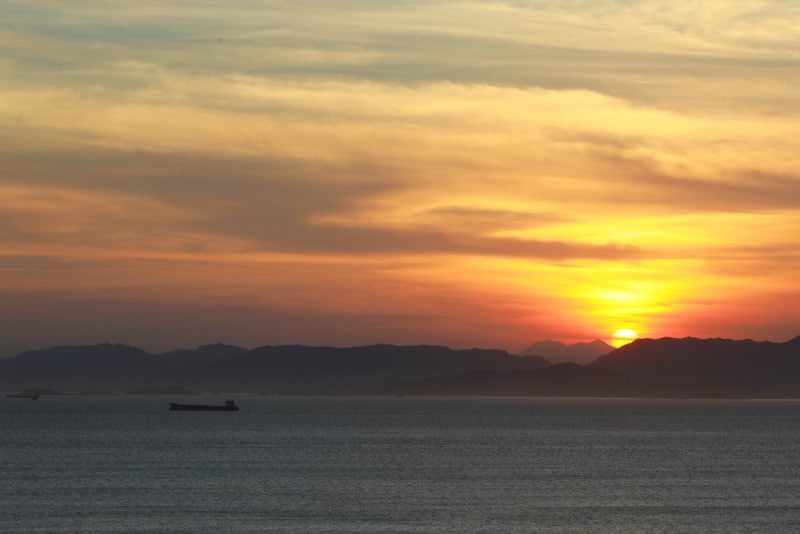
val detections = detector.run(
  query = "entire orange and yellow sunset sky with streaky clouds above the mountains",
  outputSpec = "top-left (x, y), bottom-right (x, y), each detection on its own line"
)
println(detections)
top-left (0, 0), bottom-right (800, 356)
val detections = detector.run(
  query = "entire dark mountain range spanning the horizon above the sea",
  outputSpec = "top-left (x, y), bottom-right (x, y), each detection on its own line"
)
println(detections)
top-left (0, 336), bottom-right (800, 398)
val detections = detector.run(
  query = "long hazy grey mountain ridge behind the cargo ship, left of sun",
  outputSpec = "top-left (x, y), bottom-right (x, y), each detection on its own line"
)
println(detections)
top-left (0, 343), bottom-right (550, 393)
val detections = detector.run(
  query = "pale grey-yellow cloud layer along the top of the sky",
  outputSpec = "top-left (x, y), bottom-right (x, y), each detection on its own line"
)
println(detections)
top-left (0, 0), bottom-right (798, 112)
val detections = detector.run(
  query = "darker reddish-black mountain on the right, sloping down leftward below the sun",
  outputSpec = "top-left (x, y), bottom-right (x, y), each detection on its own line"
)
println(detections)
top-left (380, 337), bottom-right (800, 398)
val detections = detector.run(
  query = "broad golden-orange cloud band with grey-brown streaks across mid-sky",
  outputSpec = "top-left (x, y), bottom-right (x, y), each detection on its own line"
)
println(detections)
top-left (4, 72), bottom-right (800, 266)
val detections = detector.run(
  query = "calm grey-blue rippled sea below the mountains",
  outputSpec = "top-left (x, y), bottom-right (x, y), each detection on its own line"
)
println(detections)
top-left (0, 397), bottom-right (800, 534)
